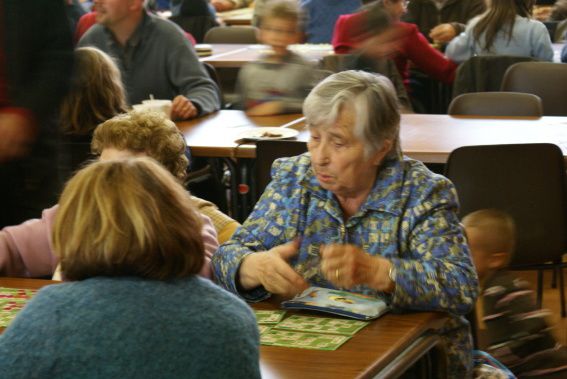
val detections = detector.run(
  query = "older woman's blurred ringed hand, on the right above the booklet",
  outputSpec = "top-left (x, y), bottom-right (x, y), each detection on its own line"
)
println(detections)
top-left (321, 244), bottom-right (395, 292)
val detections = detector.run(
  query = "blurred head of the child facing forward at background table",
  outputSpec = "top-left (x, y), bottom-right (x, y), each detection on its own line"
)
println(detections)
top-left (259, 0), bottom-right (301, 54)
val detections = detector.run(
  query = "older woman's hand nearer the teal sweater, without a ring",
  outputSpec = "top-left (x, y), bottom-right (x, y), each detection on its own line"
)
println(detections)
top-left (238, 240), bottom-right (309, 297)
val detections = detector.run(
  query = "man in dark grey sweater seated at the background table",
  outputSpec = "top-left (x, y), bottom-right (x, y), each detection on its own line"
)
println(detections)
top-left (79, 0), bottom-right (220, 119)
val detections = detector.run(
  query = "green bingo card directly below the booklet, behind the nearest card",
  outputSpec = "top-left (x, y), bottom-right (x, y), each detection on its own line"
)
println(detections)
top-left (276, 315), bottom-right (368, 336)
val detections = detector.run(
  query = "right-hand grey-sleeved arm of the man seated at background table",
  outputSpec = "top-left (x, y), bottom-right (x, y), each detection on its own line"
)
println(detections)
top-left (167, 33), bottom-right (220, 116)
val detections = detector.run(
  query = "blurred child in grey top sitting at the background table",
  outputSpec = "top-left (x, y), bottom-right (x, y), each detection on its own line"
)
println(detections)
top-left (237, 0), bottom-right (317, 116)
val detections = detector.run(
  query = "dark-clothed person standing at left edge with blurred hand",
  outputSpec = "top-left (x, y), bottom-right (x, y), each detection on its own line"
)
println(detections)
top-left (0, 0), bottom-right (73, 227)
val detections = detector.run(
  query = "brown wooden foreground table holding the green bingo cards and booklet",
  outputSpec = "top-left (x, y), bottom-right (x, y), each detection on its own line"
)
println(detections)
top-left (0, 278), bottom-right (447, 379)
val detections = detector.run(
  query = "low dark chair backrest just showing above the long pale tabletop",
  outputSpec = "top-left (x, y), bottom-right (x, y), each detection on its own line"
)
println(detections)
top-left (449, 92), bottom-right (543, 117)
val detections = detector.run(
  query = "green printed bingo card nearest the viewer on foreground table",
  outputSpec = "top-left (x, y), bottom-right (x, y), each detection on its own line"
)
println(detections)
top-left (260, 328), bottom-right (350, 350)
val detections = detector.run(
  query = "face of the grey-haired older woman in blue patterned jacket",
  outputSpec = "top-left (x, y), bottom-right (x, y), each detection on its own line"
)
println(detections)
top-left (307, 109), bottom-right (391, 197)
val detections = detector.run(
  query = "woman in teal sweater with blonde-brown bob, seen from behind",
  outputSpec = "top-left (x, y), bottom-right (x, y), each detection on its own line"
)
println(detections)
top-left (0, 158), bottom-right (260, 378)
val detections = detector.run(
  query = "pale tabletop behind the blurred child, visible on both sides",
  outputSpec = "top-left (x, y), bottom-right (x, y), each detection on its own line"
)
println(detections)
top-left (200, 44), bottom-right (334, 68)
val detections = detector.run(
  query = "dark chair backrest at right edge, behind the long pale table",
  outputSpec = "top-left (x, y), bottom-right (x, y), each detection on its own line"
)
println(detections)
top-left (502, 62), bottom-right (567, 116)
